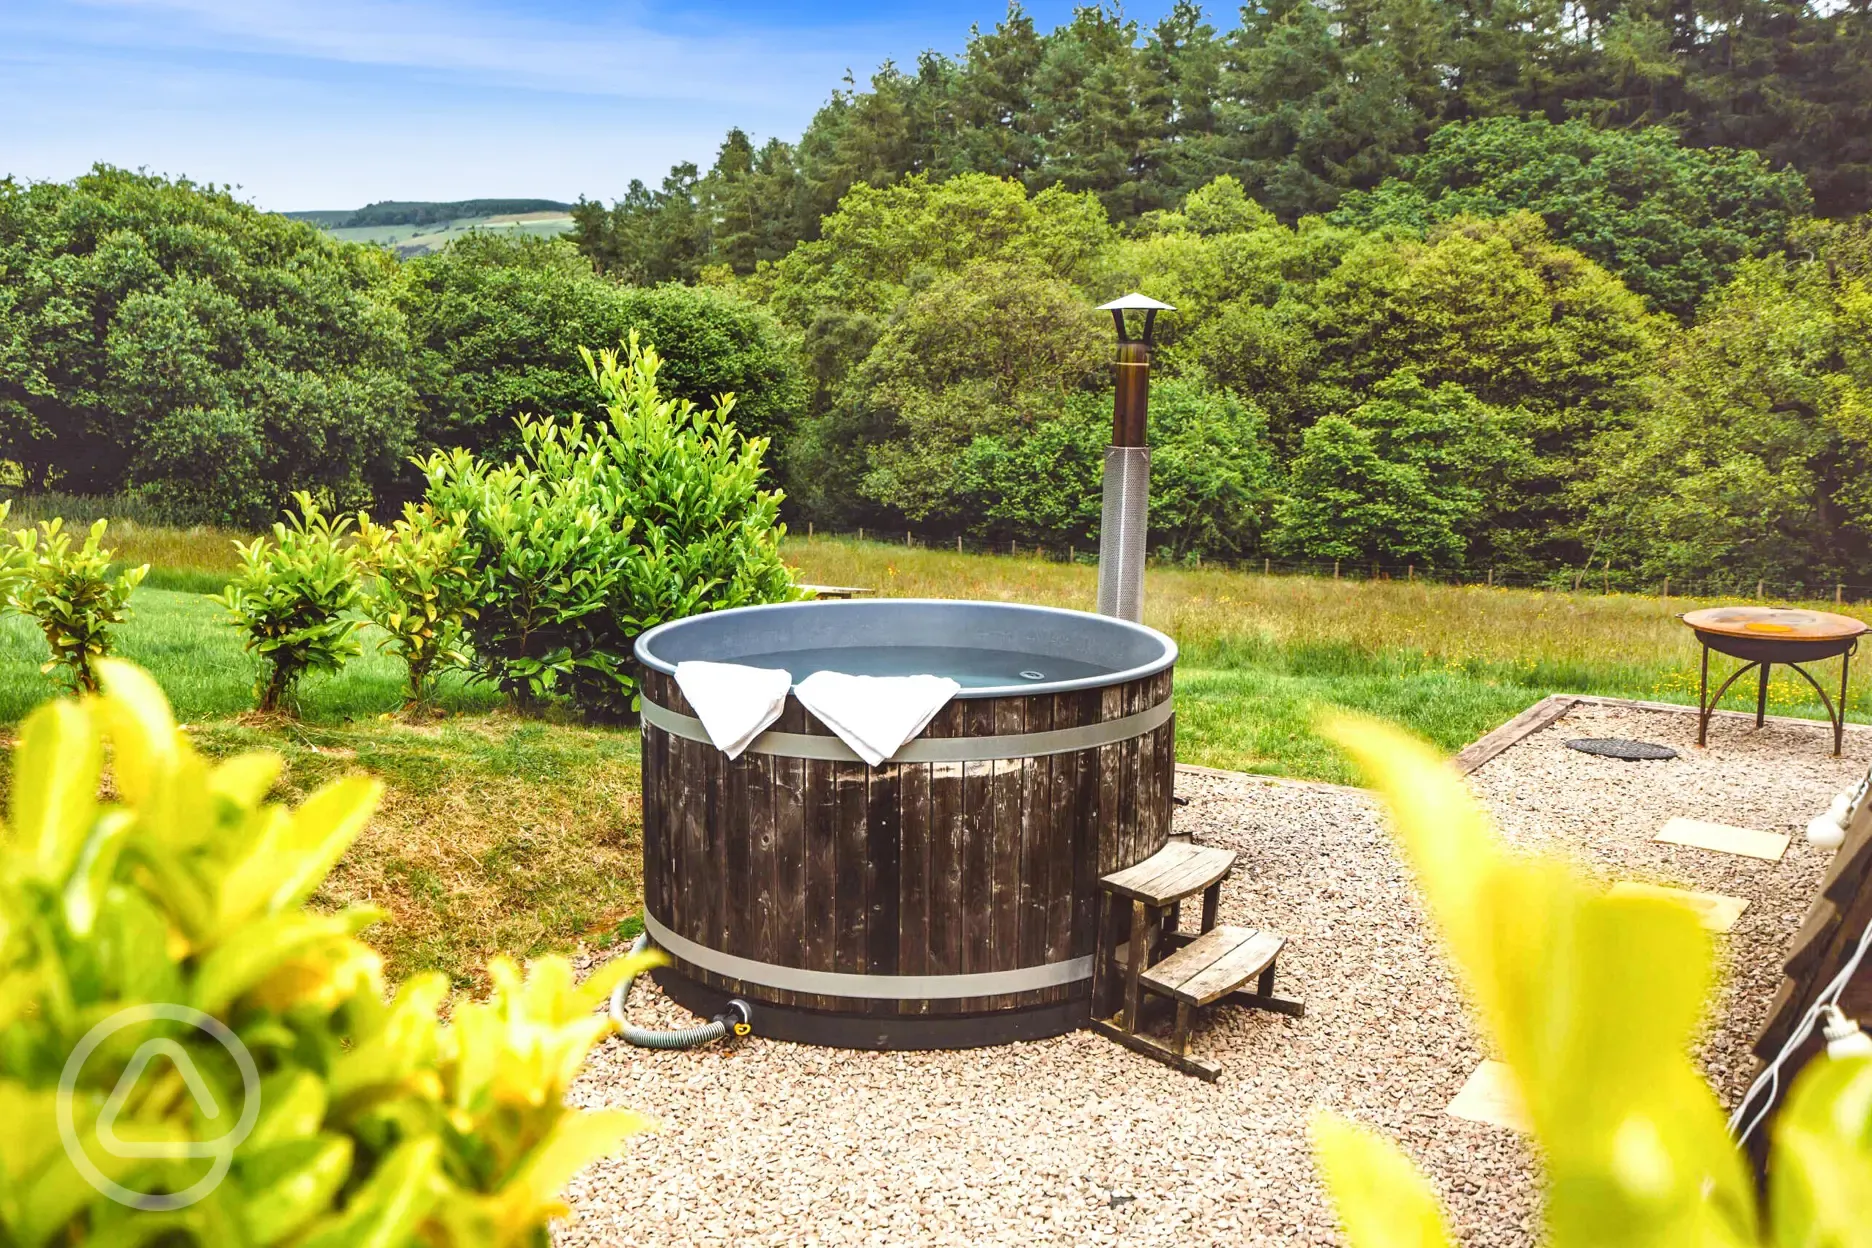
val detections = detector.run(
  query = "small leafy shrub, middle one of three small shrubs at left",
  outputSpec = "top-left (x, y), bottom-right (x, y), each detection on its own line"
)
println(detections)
top-left (215, 490), bottom-right (363, 711)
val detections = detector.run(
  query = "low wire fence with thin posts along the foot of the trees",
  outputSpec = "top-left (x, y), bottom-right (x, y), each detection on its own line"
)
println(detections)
top-left (792, 522), bottom-right (1872, 606)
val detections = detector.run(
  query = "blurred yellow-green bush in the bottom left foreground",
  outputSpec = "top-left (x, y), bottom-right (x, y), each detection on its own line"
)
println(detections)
top-left (0, 660), bottom-right (642, 1248)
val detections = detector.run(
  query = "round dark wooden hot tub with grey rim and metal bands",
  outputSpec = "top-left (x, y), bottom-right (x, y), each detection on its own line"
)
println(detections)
top-left (636, 599), bottom-right (1176, 1048)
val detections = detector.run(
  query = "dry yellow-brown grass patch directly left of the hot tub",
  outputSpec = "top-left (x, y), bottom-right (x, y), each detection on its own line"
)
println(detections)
top-left (193, 715), bottom-right (642, 984)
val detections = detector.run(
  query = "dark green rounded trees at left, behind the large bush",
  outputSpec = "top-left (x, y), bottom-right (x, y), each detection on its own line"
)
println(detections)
top-left (0, 167), bottom-right (803, 524)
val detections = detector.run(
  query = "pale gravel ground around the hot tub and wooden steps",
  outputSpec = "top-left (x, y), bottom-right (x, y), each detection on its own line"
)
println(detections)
top-left (556, 705), bottom-right (1872, 1248)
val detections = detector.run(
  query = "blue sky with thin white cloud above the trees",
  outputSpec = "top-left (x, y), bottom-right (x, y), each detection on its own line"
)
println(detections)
top-left (0, 0), bottom-right (1100, 210)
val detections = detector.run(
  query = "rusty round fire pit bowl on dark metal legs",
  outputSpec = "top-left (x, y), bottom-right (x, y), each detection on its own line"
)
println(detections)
top-left (1679, 606), bottom-right (1866, 758)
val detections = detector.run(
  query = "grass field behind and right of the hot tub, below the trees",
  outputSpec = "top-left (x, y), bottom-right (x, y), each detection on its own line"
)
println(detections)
top-left (786, 533), bottom-right (1872, 782)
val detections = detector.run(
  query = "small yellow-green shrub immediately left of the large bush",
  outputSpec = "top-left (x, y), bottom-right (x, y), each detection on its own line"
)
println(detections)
top-left (358, 503), bottom-right (477, 709)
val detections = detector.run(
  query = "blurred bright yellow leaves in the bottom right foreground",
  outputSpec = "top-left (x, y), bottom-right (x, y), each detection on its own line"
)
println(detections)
top-left (1314, 718), bottom-right (1872, 1248)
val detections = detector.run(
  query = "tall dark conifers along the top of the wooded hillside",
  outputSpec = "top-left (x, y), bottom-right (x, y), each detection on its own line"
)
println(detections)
top-left (575, 0), bottom-right (1872, 286)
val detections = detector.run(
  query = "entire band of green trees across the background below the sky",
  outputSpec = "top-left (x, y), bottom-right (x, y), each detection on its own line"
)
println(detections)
top-left (0, 0), bottom-right (1872, 586)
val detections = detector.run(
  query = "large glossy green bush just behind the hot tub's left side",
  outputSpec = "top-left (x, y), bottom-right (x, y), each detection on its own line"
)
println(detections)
top-left (425, 331), bottom-right (797, 717)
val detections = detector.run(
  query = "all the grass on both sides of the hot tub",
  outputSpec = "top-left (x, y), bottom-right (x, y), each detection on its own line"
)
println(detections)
top-left (0, 538), bottom-right (1842, 982)
